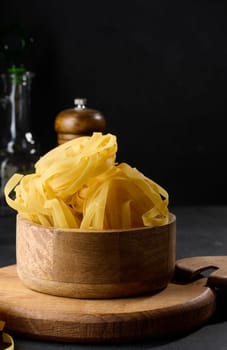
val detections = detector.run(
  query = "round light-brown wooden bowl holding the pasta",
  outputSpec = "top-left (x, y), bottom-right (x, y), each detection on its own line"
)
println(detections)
top-left (16, 214), bottom-right (176, 298)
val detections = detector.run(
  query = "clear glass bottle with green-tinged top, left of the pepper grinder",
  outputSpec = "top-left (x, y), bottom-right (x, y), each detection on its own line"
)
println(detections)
top-left (0, 67), bottom-right (39, 215)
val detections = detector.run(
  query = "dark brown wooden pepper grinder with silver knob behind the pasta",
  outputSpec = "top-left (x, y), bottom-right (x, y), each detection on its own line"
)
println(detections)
top-left (54, 98), bottom-right (106, 145)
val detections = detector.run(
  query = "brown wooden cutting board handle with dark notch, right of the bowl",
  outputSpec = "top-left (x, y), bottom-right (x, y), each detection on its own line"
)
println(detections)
top-left (175, 256), bottom-right (227, 288)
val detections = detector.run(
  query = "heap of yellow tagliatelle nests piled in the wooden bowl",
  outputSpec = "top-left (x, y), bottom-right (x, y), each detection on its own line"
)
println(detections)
top-left (5, 133), bottom-right (169, 230)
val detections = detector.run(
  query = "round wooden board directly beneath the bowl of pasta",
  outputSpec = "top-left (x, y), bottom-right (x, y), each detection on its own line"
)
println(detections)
top-left (0, 265), bottom-right (215, 343)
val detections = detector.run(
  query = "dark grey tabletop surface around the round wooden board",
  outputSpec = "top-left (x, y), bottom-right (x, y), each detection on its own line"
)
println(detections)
top-left (0, 206), bottom-right (227, 350)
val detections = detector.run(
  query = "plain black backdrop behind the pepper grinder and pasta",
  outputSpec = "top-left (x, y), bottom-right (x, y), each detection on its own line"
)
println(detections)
top-left (0, 0), bottom-right (227, 204)
